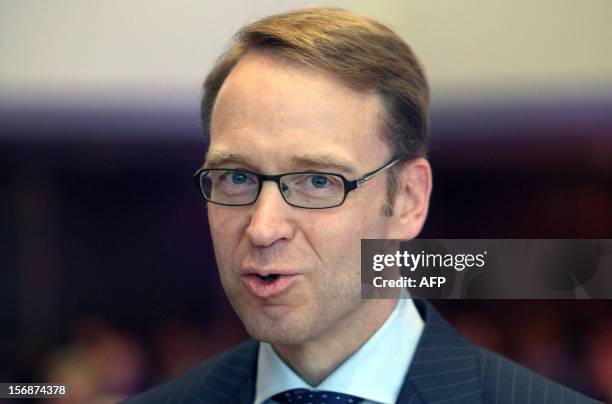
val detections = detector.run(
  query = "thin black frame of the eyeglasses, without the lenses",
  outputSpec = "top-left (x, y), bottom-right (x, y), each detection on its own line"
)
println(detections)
top-left (193, 157), bottom-right (400, 209)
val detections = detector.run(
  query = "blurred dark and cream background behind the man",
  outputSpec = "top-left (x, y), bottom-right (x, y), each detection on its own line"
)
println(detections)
top-left (0, 0), bottom-right (612, 403)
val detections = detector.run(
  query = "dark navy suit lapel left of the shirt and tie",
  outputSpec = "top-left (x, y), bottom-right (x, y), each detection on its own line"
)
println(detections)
top-left (193, 340), bottom-right (259, 404)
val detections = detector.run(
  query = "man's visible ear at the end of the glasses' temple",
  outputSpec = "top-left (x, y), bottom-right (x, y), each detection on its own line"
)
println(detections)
top-left (389, 157), bottom-right (432, 239)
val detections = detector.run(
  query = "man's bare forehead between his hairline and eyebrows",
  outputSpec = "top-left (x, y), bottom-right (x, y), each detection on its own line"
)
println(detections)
top-left (210, 53), bottom-right (388, 169)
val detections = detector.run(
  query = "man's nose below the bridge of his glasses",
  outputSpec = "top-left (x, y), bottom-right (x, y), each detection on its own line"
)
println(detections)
top-left (246, 181), bottom-right (295, 247)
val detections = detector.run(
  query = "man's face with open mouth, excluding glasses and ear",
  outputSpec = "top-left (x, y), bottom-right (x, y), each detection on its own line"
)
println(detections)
top-left (206, 53), bottom-right (392, 344)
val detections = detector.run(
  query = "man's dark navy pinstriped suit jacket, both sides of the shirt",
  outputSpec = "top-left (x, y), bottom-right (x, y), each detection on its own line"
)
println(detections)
top-left (126, 300), bottom-right (598, 404)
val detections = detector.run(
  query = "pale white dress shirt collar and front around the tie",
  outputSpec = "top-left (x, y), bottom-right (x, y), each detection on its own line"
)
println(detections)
top-left (255, 295), bottom-right (424, 404)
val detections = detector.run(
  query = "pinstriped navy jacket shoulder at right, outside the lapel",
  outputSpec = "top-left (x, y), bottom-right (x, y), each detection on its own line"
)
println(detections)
top-left (475, 347), bottom-right (600, 404)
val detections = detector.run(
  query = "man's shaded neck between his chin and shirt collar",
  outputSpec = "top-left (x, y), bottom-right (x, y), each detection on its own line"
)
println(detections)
top-left (274, 299), bottom-right (397, 386)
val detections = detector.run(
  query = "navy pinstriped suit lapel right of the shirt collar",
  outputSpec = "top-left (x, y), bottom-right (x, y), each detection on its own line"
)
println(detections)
top-left (397, 299), bottom-right (482, 404)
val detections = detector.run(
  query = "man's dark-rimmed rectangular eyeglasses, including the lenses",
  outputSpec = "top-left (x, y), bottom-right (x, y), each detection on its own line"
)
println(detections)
top-left (193, 158), bottom-right (399, 209)
